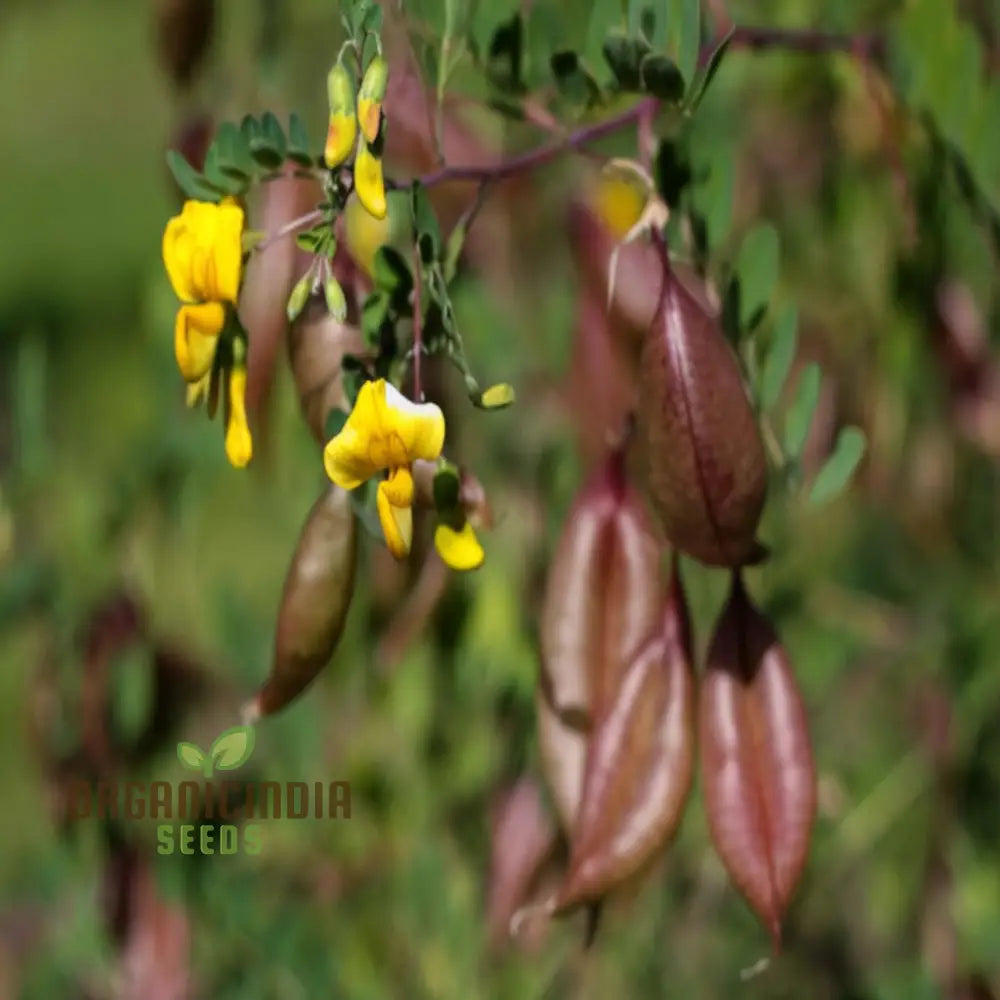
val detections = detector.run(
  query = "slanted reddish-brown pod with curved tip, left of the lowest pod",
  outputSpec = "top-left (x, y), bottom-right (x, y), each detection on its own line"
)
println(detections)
top-left (556, 570), bottom-right (694, 910)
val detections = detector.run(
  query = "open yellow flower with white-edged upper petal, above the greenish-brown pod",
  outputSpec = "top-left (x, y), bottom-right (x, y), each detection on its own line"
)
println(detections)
top-left (323, 379), bottom-right (445, 559)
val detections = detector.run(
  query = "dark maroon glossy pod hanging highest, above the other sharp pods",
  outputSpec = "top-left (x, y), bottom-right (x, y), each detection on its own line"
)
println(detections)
top-left (639, 246), bottom-right (767, 567)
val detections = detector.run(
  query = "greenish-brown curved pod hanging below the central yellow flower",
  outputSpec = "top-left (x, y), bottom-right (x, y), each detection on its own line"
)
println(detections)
top-left (244, 484), bottom-right (358, 722)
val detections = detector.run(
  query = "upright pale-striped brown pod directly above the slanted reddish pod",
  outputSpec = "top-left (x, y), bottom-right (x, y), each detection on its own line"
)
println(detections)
top-left (541, 452), bottom-right (662, 728)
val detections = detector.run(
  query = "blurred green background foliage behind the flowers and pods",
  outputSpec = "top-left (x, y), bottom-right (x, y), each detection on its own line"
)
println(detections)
top-left (0, 0), bottom-right (1000, 1000)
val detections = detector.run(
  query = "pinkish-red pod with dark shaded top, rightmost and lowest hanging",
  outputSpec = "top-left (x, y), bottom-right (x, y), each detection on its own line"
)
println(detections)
top-left (699, 574), bottom-right (816, 949)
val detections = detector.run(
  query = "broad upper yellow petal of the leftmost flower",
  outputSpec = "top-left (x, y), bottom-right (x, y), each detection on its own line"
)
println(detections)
top-left (163, 199), bottom-right (243, 305)
